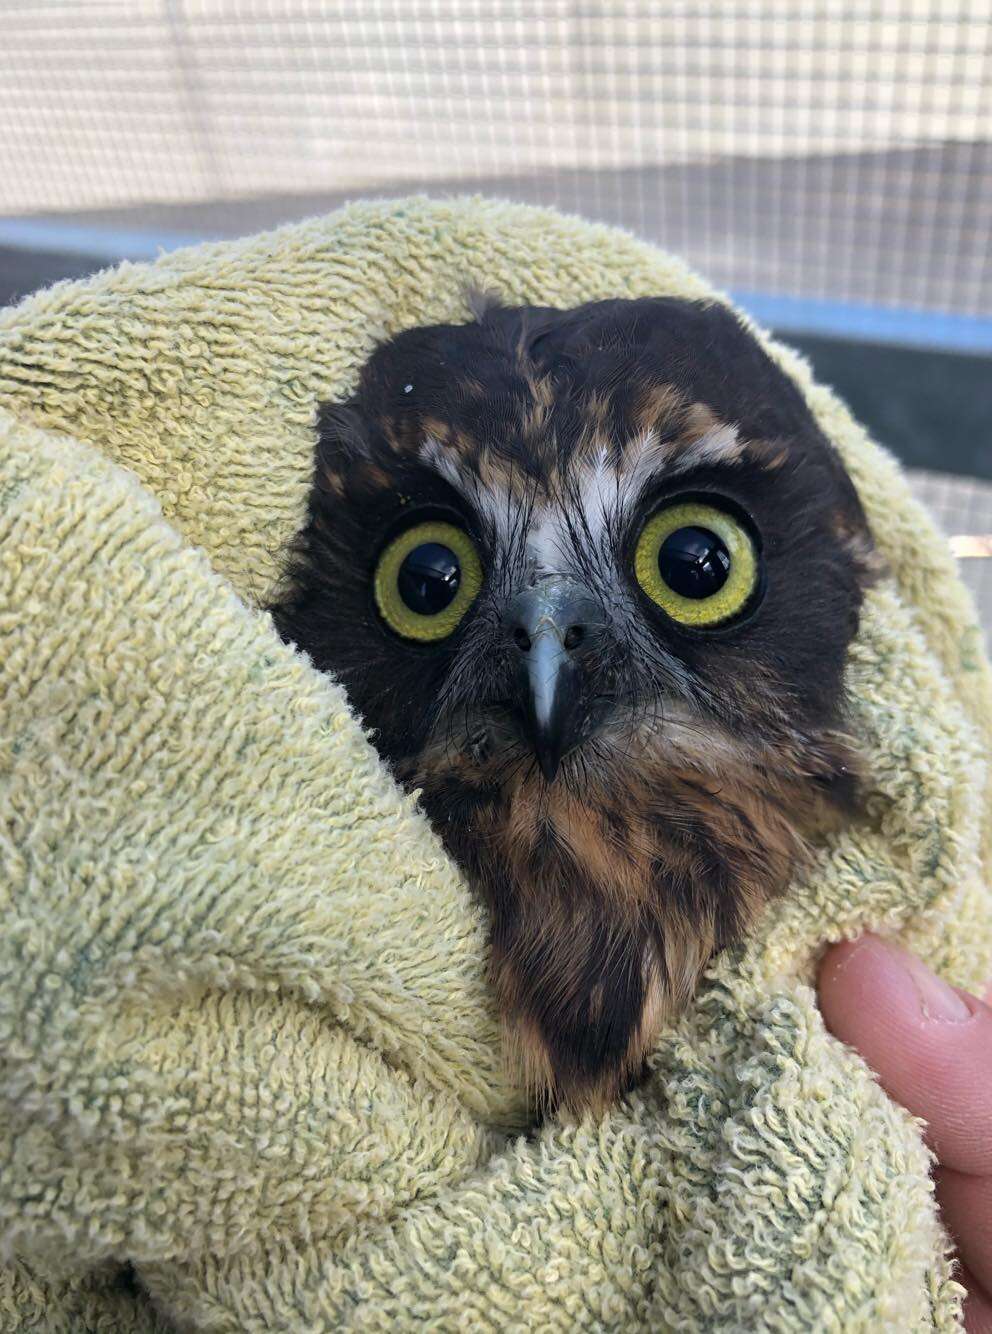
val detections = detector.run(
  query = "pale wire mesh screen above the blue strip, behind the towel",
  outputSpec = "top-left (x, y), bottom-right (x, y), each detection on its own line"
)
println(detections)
top-left (0, 0), bottom-right (992, 315)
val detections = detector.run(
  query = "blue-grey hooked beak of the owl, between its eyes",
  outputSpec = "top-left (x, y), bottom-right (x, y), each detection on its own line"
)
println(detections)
top-left (507, 575), bottom-right (601, 783)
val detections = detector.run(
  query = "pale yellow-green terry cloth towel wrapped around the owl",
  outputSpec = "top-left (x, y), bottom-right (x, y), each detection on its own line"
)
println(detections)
top-left (0, 199), bottom-right (992, 1334)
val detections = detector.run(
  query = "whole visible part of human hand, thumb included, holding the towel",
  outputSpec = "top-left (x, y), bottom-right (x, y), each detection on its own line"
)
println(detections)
top-left (820, 935), bottom-right (992, 1334)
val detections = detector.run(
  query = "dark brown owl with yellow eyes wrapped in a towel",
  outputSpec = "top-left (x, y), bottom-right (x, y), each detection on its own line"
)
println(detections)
top-left (272, 297), bottom-right (875, 1111)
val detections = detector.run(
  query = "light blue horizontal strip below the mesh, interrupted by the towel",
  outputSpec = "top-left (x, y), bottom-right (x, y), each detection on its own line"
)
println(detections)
top-left (0, 217), bottom-right (992, 354)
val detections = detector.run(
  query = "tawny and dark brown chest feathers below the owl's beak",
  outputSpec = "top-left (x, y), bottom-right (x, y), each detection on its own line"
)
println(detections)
top-left (417, 739), bottom-right (816, 1107)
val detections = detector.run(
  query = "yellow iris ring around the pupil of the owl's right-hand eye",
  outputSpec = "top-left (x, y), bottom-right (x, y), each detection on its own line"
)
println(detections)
top-left (633, 500), bottom-right (760, 626)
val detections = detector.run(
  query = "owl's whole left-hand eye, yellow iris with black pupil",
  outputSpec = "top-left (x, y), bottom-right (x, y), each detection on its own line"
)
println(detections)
top-left (373, 523), bottom-right (483, 643)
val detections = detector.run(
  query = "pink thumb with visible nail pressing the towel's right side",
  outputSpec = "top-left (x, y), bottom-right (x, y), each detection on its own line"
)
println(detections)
top-left (820, 935), bottom-right (992, 1177)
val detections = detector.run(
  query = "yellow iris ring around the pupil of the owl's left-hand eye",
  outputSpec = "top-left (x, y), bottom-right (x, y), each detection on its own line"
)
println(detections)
top-left (373, 522), bottom-right (483, 643)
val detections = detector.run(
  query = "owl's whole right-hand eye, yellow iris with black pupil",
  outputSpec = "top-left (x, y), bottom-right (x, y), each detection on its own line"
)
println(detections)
top-left (633, 500), bottom-right (760, 626)
